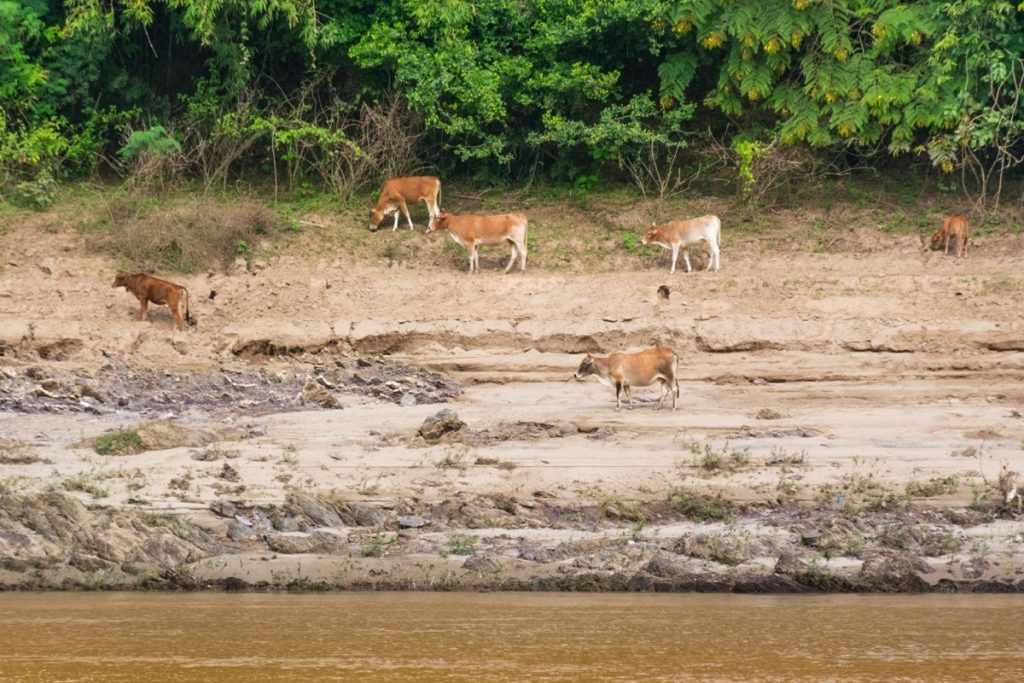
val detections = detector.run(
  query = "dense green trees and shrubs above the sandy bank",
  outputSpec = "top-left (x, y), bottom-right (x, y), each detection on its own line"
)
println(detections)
top-left (0, 0), bottom-right (1024, 204)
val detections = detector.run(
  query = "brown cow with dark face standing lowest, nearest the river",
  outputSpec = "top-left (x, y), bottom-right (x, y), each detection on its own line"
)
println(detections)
top-left (572, 346), bottom-right (679, 411)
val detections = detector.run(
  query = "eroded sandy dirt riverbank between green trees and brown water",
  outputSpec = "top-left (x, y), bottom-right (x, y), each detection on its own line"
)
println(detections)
top-left (0, 225), bottom-right (1024, 591)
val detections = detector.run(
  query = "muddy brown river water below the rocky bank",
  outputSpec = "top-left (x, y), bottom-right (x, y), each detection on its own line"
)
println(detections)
top-left (0, 593), bottom-right (1024, 683)
